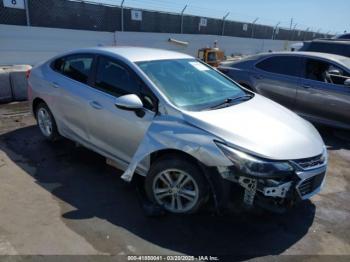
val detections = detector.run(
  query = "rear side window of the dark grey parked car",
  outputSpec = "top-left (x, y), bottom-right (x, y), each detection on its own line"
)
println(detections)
top-left (256, 56), bottom-right (302, 77)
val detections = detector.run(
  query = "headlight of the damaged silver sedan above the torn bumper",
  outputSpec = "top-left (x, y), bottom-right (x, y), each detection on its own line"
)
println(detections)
top-left (216, 142), bottom-right (294, 177)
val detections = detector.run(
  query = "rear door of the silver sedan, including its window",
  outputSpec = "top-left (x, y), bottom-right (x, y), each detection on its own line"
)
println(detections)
top-left (51, 54), bottom-right (94, 140)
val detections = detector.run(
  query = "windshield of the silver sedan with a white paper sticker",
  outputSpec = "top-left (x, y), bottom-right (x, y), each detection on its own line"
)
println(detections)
top-left (137, 59), bottom-right (246, 111)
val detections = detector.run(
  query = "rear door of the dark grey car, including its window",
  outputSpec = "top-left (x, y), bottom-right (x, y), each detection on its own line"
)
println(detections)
top-left (251, 55), bottom-right (302, 110)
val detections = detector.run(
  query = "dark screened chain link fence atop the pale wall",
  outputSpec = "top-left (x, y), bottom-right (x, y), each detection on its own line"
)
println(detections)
top-left (0, 0), bottom-right (330, 41)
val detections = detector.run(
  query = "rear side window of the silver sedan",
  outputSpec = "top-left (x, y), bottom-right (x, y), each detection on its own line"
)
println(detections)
top-left (60, 55), bottom-right (94, 84)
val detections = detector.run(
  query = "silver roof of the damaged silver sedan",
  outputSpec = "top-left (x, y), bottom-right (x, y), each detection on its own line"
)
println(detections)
top-left (73, 46), bottom-right (193, 62)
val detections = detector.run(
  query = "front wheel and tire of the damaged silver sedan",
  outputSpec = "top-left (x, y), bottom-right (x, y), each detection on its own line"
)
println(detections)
top-left (145, 157), bottom-right (208, 214)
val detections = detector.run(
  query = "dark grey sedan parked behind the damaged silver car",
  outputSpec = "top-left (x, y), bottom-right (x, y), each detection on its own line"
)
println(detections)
top-left (219, 52), bottom-right (350, 129)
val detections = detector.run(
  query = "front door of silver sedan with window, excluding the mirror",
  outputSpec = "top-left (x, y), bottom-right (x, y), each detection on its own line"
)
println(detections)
top-left (88, 56), bottom-right (155, 163)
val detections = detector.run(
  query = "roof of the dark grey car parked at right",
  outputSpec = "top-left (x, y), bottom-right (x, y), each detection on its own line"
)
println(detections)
top-left (245, 51), bottom-right (350, 68)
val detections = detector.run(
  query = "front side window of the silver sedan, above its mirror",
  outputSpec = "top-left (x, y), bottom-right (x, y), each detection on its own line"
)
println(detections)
top-left (95, 56), bottom-right (139, 97)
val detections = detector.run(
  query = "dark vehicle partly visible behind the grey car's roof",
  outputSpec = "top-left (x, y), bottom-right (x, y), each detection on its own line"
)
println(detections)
top-left (299, 39), bottom-right (350, 57)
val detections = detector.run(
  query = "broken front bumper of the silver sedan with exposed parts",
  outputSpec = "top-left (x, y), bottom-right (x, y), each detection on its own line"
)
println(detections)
top-left (218, 163), bottom-right (327, 212)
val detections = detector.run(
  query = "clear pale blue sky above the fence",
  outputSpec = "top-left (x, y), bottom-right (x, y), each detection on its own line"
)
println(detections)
top-left (86, 0), bottom-right (350, 34)
